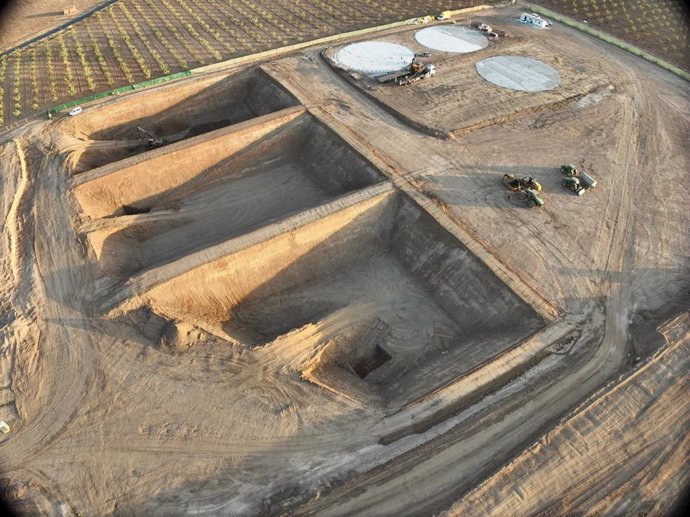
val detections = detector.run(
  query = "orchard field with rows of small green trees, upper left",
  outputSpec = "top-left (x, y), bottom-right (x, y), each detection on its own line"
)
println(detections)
top-left (0, 0), bottom-right (481, 126)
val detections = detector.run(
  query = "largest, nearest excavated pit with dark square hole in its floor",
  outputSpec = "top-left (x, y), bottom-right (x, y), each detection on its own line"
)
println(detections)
top-left (134, 190), bottom-right (545, 405)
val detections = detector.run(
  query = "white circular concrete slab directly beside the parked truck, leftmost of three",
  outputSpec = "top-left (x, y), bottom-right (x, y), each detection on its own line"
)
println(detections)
top-left (333, 41), bottom-right (414, 76)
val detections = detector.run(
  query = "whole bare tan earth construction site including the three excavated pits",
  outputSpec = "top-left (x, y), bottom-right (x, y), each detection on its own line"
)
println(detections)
top-left (0, 5), bottom-right (690, 515)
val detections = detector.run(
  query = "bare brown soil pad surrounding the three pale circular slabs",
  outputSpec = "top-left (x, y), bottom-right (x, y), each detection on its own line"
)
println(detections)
top-left (325, 12), bottom-right (615, 135)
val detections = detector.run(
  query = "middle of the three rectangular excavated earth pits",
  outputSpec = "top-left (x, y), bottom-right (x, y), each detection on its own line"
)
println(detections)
top-left (78, 110), bottom-right (383, 278)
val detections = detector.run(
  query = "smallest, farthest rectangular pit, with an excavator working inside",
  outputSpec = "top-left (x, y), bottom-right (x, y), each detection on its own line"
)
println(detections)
top-left (64, 68), bottom-right (299, 173)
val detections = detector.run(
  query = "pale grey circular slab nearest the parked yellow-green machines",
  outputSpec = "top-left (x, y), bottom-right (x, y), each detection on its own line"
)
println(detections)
top-left (475, 56), bottom-right (561, 92)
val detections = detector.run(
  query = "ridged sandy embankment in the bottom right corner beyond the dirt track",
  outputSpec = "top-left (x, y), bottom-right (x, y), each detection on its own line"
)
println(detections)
top-left (446, 312), bottom-right (690, 516)
